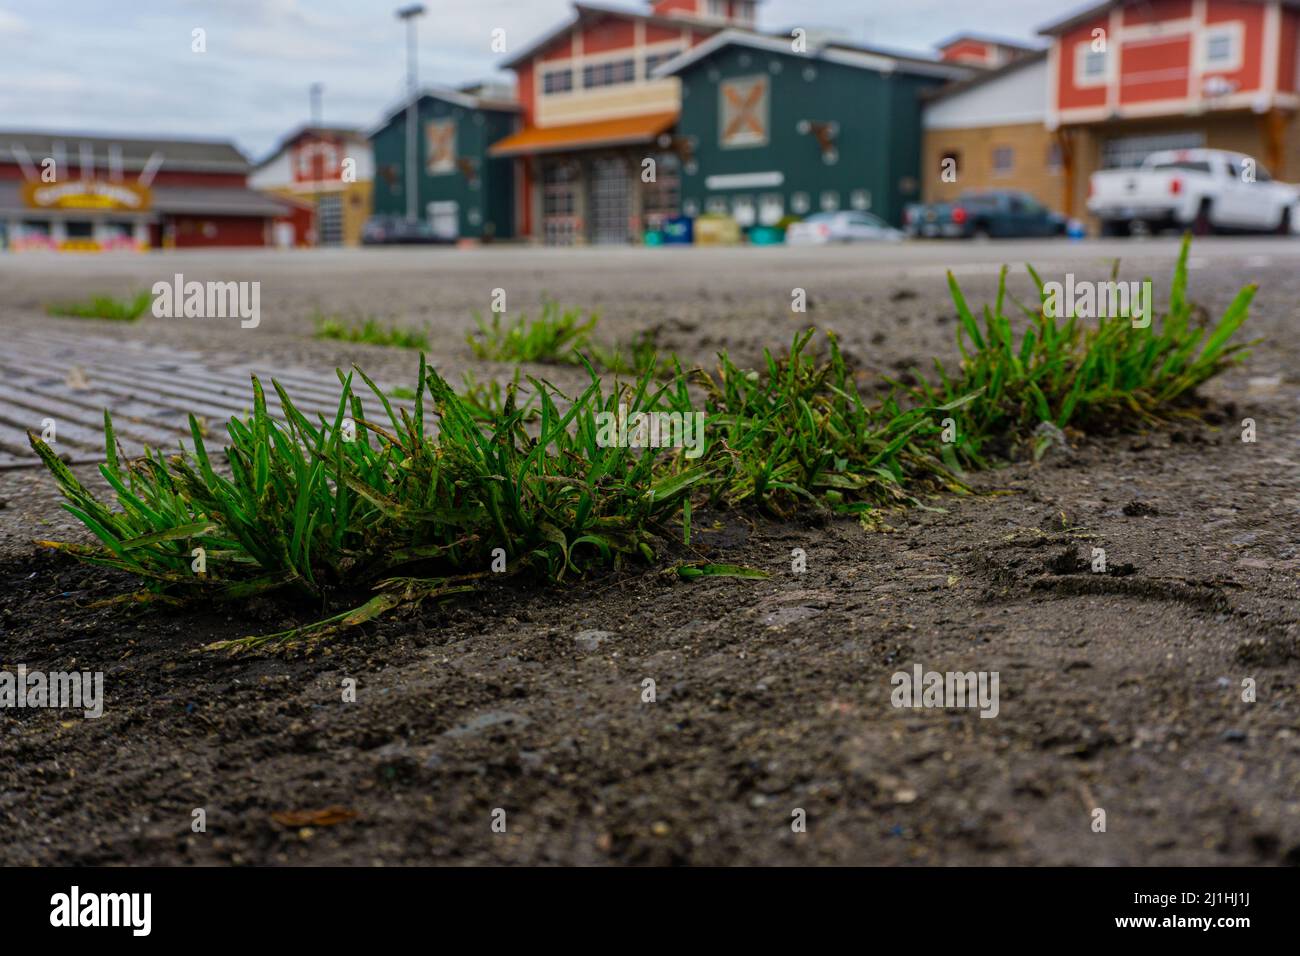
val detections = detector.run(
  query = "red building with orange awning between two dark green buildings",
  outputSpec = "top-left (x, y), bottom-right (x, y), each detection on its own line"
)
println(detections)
top-left (490, 0), bottom-right (757, 245)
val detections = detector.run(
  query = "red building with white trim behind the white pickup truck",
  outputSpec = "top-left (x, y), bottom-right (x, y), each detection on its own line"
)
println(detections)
top-left (1041, 0), bottom-right (1300, 218)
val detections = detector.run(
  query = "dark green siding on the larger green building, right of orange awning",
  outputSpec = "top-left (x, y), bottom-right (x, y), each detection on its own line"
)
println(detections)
top-left (677, 44), bottom-right (943, 225)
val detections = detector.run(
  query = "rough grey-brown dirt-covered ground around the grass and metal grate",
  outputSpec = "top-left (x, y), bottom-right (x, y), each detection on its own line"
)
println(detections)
top-left (0, 241), bottom-right (1300, 865)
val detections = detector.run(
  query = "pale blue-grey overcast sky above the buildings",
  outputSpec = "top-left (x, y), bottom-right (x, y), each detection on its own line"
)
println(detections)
top-left (0, 0), bottom-right (1080, 160)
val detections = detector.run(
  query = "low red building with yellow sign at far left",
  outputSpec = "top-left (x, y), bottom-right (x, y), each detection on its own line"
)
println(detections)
top-left (0, 131), bottom-right (302, 251)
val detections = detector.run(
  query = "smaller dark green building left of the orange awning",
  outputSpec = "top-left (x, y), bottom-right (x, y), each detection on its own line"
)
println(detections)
top-left (369, 87), bottom-right (519, 239)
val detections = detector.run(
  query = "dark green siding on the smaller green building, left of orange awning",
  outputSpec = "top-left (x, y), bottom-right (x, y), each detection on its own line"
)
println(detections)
top-left (371, 96), bottom-right (515, 239)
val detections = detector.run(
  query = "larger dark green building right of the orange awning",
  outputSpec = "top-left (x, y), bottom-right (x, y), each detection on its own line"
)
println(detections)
top-left (655, 30), bottom-right (970, 228)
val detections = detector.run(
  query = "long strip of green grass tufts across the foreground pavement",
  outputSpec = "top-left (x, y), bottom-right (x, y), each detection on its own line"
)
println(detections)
top-left (30, 238), bottom-right (1253, 648)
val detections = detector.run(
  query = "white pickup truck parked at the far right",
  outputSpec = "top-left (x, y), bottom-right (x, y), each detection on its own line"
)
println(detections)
top-left (1088, 150), bottom-right (1300, 235)
